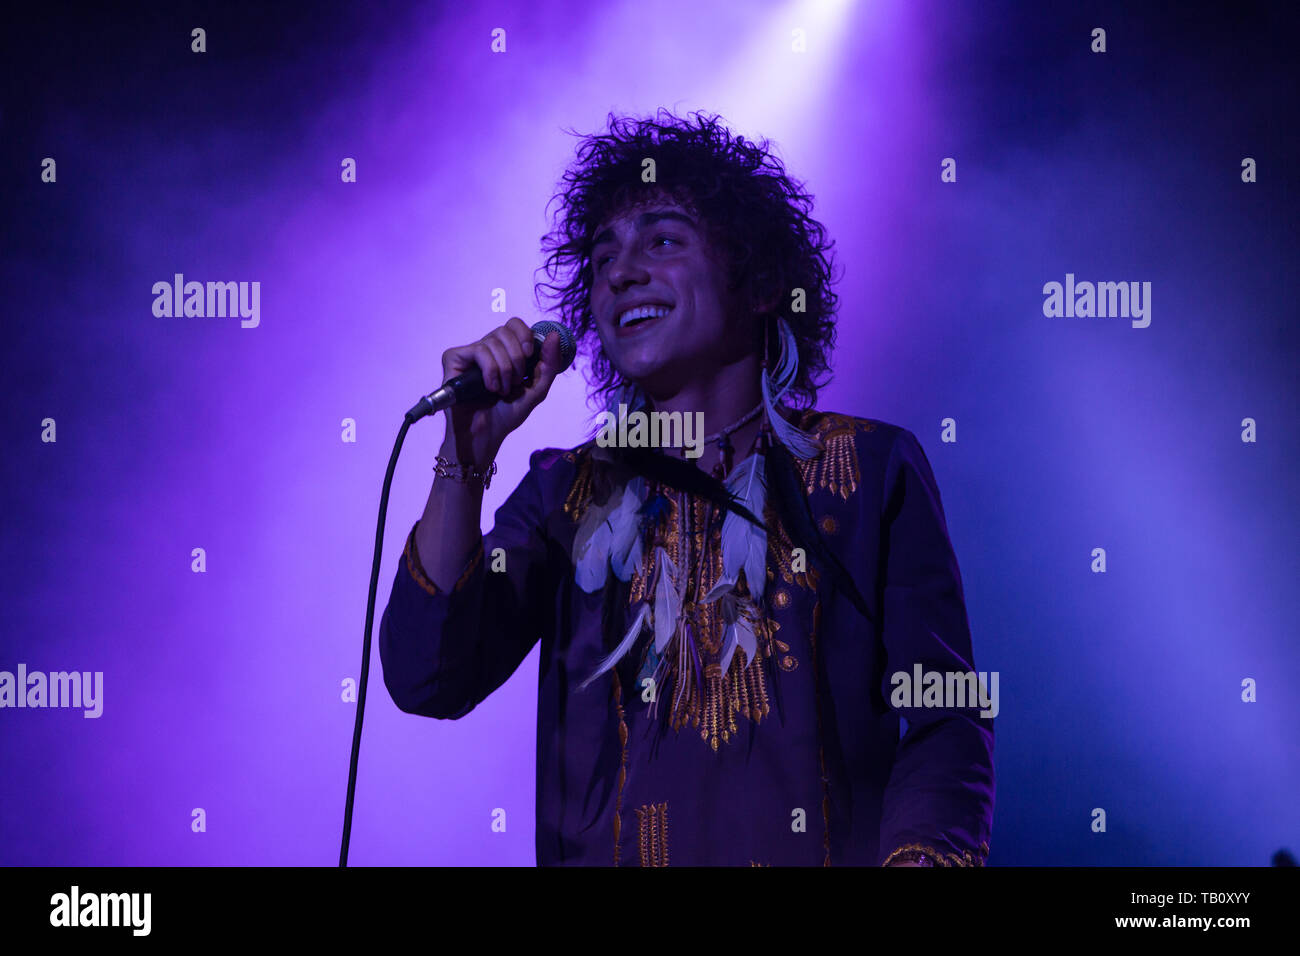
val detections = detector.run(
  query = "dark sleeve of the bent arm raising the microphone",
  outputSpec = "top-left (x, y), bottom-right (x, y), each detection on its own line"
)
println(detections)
top-left (380, 451), bottom-right (555, 719)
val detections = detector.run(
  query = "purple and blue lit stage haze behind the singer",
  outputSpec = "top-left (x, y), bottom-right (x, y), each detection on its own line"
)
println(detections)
top-left (0, 0), bottom-right (1300, 865)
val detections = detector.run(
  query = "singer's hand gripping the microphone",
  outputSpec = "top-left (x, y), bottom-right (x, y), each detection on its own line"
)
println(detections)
top-left (442, 316), bottom-right (560, 467)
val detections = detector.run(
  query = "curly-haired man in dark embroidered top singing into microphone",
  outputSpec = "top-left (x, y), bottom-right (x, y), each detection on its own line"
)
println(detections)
top-left (380, 111), bottom-right (995, 866)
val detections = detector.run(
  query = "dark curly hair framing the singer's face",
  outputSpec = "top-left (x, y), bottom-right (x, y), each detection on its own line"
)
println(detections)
top-left (533, 109), bottom-right (839, 416)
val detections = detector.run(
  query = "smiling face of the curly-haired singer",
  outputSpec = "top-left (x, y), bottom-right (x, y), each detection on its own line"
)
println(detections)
top-left (592, 198), bottom-right (754, 395)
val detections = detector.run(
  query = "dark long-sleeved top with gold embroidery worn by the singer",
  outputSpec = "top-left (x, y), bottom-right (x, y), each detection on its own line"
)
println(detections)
top-left (380, 410), bottom-right (995, 866)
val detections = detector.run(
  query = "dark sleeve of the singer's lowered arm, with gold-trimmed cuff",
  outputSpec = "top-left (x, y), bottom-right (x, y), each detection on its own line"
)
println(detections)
top-left (880, 429), bottom-right (997, 866)
